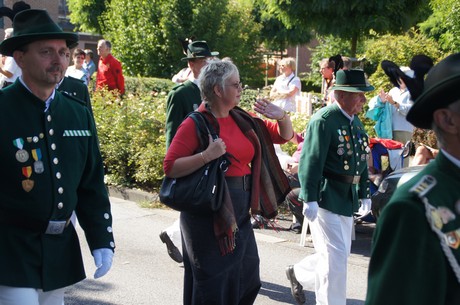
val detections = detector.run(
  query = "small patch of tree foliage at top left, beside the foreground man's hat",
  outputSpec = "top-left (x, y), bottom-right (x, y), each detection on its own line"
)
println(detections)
top-left (67, 0), bottom-right (110, 34)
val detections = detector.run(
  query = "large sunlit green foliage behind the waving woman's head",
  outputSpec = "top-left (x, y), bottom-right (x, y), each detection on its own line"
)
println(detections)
top-left (98, 0), bottom-right (260, 83)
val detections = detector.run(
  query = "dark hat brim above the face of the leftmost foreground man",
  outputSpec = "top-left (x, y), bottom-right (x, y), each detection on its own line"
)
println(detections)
top-left (0, 32), bottom-right (78, 56)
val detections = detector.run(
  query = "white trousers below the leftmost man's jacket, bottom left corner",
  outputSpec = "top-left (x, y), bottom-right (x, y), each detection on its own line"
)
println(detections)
top-left (0, 285), bottom-right (66, 305)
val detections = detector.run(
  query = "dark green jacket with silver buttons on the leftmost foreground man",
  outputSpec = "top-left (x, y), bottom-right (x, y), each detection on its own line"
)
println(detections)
top-left (0, 80), bottom-right (115, 291)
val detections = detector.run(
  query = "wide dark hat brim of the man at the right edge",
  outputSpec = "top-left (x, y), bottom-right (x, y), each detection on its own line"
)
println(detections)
top-left (406, 74), bottom-right (460, 129)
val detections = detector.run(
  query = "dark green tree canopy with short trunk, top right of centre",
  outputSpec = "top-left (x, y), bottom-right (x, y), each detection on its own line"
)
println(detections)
top-left (263, 0), bottom-right (428, 56)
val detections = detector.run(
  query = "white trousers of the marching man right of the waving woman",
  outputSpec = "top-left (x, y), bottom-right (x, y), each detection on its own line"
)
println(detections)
top-left (294, 208), bottom-right (353, 305)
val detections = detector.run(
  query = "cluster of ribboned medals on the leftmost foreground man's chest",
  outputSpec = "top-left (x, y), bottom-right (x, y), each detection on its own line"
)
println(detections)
top-left (13, 134), bottom-right (45, 192)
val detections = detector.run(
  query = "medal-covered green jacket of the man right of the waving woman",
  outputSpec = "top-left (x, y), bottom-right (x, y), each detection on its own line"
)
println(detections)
top-left (299, 104), bottom-right (370, 216)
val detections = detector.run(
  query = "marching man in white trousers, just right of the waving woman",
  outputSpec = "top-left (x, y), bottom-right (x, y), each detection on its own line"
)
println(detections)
top-left (286, 70), bottom-right (374, 305)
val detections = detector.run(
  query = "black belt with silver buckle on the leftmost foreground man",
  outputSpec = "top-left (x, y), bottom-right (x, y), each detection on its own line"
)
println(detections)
top-left (0, 211), bottom-right (70, 235)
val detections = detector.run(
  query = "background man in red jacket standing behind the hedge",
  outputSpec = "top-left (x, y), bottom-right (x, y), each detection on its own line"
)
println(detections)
top-left (96, 39), bottom-right (125, 95)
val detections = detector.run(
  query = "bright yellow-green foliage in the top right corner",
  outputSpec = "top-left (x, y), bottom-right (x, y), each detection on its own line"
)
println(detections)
top-left (420, 0), bottom-right (460, 53)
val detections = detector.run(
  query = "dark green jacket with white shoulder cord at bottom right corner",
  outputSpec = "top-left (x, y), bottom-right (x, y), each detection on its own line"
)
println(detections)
top-left (365, 152), bottom-right (460, 305)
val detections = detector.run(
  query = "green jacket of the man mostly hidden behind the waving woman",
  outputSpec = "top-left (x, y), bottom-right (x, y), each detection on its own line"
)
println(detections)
top-left (166, 80), bottom-right (201, 148)
